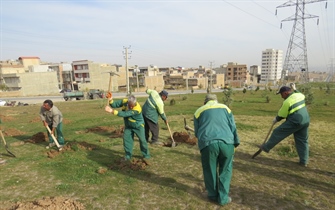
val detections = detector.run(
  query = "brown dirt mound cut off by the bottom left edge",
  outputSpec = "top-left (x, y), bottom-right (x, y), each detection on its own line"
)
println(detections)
top-left (5, 197), bottom-right (85, 210)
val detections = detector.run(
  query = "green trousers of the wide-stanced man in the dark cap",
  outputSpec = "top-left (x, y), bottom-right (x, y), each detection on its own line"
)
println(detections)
top-left (262, 120), bottom-right (309, 164)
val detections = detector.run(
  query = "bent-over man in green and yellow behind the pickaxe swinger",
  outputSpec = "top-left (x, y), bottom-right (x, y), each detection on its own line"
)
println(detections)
top-left (143, 89), bottom-right (168, 145)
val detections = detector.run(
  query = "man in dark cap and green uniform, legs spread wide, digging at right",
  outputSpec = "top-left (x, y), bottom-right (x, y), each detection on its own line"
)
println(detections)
top-left (261, 83), bottom-right (310, 167)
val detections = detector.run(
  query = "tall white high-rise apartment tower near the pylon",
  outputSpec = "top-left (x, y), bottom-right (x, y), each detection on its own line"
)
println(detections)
top-left (260, 49), bottom-right (283, 85)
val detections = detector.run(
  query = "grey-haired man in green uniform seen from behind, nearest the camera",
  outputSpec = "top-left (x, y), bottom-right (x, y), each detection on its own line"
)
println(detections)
top-left (194, 94), bottom-right (240, 205)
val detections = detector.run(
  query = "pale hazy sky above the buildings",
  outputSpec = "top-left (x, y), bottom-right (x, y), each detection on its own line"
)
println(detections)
top-left (0, 0), bottom-right (335, 71)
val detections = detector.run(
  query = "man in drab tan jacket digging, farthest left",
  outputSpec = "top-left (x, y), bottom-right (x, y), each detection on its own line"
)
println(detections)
top-left (40, 99), bottom-right (65, 149)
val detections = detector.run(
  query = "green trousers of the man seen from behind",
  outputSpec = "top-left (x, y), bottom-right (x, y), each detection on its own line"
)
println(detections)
top-left (201, 140), bottom-right (234, 205)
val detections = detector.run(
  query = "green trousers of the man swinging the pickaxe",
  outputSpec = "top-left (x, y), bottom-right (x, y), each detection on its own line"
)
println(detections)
top-left (123, 126), bottom-right (150, 159)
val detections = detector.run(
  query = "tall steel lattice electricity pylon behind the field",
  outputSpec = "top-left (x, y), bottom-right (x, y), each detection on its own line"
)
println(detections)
top-left (276, 0), bottom-right (327, 82)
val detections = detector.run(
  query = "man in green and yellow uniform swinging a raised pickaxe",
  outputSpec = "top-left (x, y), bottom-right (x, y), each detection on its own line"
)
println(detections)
top-left (105, 95), bottom-right (150, 163)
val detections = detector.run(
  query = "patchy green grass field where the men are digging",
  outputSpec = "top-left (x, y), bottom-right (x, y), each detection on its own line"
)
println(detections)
top-left (0, 84), bottom-right (335, 210)
